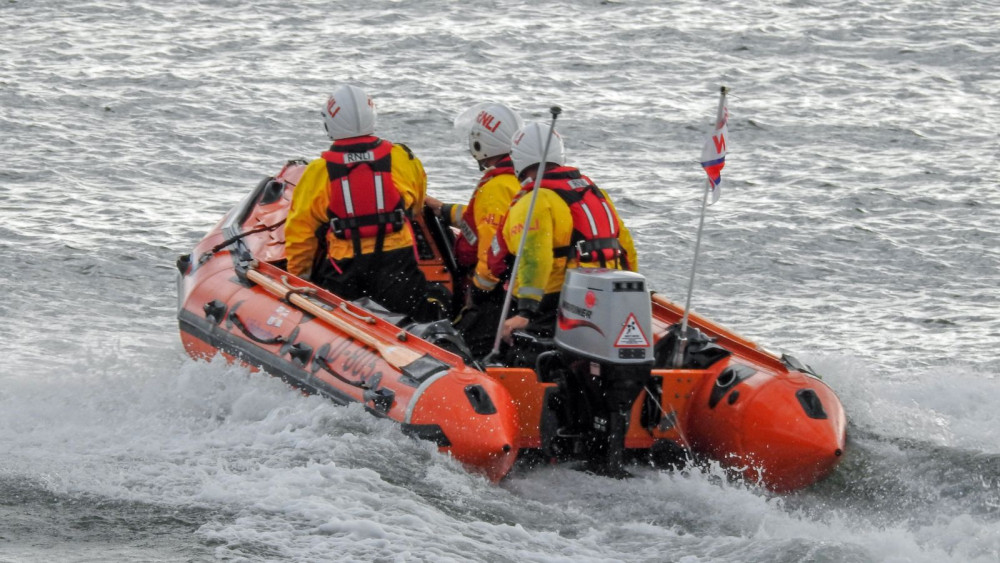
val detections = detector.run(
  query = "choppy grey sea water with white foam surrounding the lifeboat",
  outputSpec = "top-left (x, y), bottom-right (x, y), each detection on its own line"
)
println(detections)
top-left (0, 0), bottom-right (1000, 563)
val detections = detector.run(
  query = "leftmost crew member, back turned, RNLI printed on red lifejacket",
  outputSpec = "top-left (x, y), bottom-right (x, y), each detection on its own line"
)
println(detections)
top-left (285, 86), bottom-right (447, 321)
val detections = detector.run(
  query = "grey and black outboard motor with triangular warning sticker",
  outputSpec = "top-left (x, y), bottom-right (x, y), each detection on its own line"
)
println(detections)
top-left (540, 268), bottom-right (653, 476)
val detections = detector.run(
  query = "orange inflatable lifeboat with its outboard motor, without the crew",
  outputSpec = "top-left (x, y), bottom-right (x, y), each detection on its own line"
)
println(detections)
top-left (178, 161), bottom-right (846, 492)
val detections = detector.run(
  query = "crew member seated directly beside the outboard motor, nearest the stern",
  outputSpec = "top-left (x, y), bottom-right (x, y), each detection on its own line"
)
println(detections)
top-left (488, 123), bottom-right (638, 343)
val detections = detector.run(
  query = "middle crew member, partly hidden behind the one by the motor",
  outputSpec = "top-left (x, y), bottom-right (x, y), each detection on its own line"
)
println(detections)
top-left (427, 102), bottom-right (523, 357)
